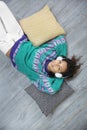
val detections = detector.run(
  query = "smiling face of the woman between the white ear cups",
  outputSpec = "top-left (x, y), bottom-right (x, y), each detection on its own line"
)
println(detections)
top-left (47, 60), bottom-right (67, 74)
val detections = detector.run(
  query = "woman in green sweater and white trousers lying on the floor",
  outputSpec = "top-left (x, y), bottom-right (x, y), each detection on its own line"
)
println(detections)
top-left (0, 1), bottom-right (80, 94)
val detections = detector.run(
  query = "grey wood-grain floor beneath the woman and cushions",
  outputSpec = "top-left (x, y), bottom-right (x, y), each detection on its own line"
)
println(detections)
top-left (0, 0), bottom-right (87, 130)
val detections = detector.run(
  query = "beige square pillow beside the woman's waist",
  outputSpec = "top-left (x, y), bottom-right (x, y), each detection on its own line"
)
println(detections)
top-left (19, 5), bottom-right (65, 46)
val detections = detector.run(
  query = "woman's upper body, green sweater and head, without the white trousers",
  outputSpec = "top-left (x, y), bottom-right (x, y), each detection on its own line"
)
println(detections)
top-left (6, 35), bottom-right (80, 94)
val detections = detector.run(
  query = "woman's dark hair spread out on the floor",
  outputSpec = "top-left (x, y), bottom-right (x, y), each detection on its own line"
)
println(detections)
top-left (49, 55), bottom-right (81, 78)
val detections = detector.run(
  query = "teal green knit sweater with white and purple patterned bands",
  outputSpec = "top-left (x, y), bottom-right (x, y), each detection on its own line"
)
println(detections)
top-left (10, 35), bottom-right (67, 94)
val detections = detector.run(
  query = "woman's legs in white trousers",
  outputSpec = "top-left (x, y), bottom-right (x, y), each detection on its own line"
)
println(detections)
top-left (0, 1), bottom-right (23, 54)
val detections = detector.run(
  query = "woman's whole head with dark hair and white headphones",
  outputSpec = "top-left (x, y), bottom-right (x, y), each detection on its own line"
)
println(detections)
top-left (48, 56), bottom-right (81, 78)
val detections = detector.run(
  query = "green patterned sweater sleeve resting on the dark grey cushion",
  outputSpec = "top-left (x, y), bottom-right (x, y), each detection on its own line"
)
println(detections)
top-left (34, 75), bottom-right (63, 95)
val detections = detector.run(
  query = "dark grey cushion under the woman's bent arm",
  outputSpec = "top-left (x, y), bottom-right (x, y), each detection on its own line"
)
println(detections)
top-left (25, 82), bottom-right (74, 116)
